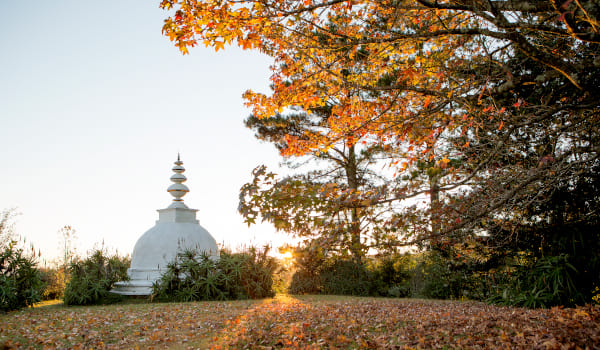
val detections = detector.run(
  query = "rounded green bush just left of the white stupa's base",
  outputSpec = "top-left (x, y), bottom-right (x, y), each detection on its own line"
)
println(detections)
top-left (63, 249), bottom-right (129, 305)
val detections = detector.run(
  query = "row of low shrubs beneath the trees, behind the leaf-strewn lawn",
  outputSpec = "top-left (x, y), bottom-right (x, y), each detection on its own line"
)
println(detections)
top-left (289, 242), bottom-right (489, 300)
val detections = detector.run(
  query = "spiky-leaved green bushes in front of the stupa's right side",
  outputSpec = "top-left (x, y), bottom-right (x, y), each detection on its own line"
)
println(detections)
top-left (152, 247), bottom-right (279, 301)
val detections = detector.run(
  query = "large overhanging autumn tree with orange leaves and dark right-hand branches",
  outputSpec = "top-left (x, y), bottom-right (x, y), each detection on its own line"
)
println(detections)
top-left (161, 0), bottom-right (600, 243)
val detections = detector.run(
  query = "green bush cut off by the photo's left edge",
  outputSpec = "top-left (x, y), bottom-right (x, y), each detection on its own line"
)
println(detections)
top-left (0, 241), bottom-right (44, 312)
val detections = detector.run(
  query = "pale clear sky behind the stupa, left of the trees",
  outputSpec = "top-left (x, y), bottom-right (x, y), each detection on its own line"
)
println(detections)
top-left (0, 0), bottom-right (285, 259)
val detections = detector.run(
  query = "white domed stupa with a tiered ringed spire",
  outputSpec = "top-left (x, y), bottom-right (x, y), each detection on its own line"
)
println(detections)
top-left (111, 154), bottom-right (219, 295)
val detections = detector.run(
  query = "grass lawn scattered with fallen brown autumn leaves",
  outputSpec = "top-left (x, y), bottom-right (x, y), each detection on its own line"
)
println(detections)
top-left (0, 295), bottom-right (600, 349)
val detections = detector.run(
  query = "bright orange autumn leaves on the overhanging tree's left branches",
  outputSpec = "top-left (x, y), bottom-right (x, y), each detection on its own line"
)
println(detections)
top-left (162, 0), bottom-right (472, 161)
